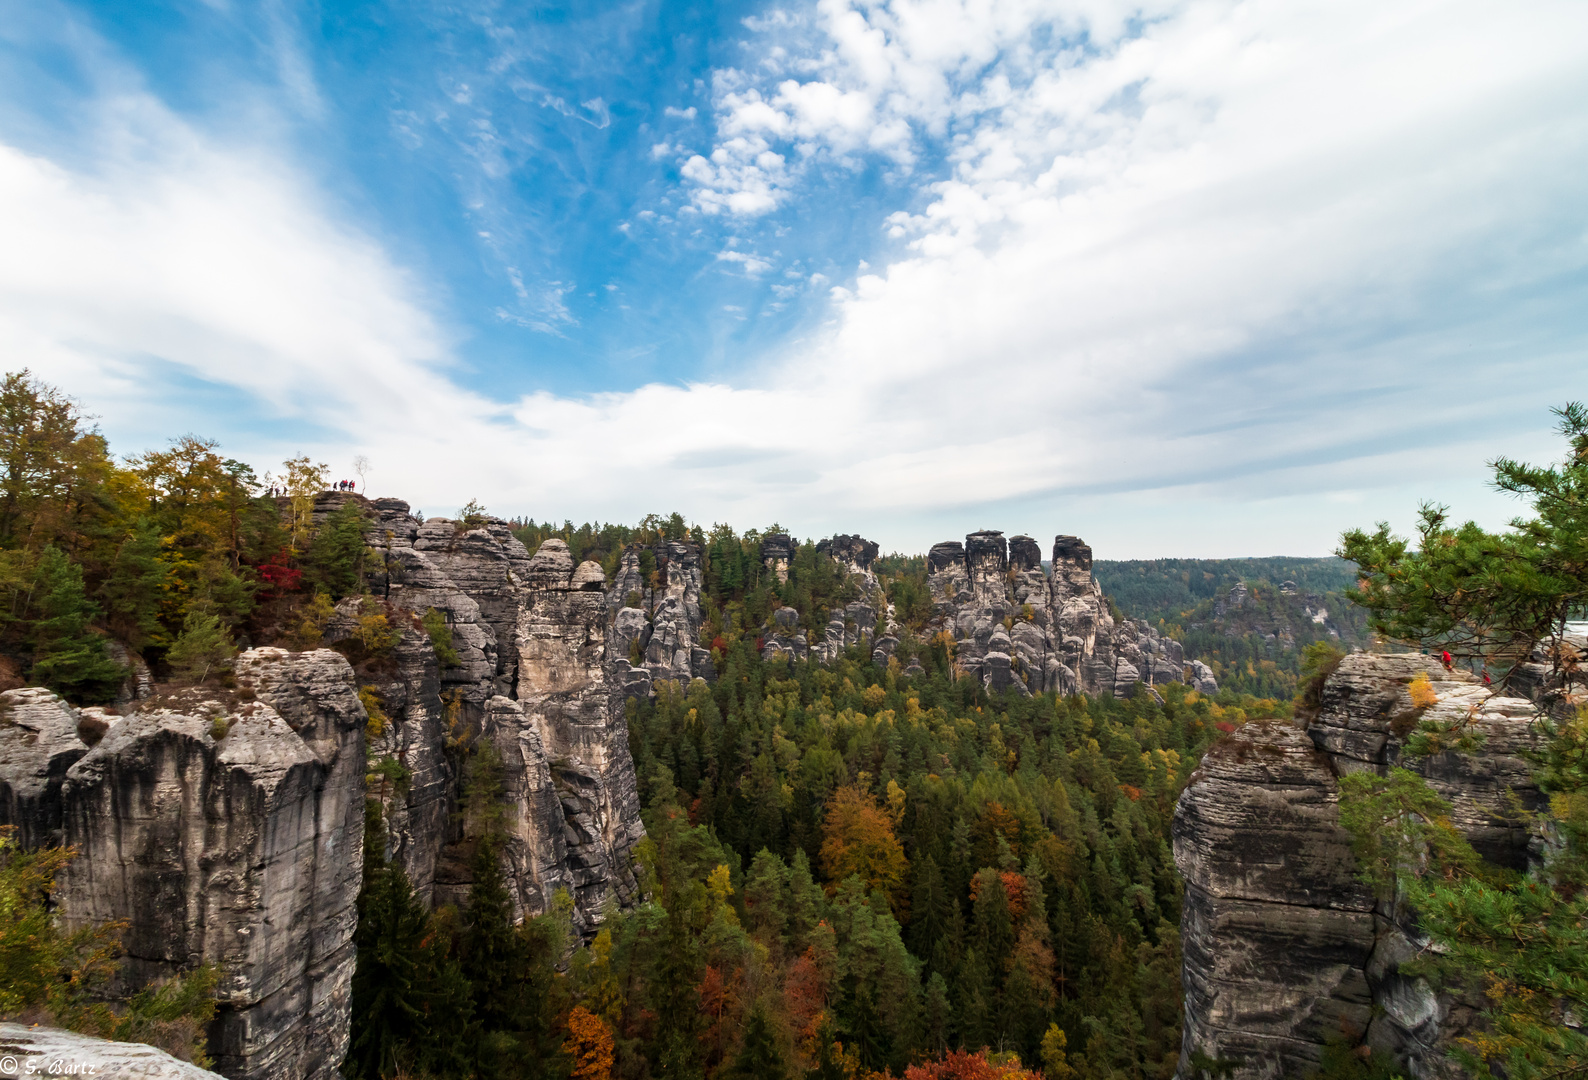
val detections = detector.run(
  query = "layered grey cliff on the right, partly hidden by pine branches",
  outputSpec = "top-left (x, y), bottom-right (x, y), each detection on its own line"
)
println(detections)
top-left (1174, 653), bottom-right (1542, 1080)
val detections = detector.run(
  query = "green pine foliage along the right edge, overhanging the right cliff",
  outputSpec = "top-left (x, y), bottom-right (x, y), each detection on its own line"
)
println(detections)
top-left (1340, 403), bottom-right (1588, 1080)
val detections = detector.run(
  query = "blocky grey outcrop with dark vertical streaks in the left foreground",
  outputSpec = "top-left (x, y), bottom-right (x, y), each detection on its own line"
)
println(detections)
top-left (0, 650), bottom-right (367, 1080)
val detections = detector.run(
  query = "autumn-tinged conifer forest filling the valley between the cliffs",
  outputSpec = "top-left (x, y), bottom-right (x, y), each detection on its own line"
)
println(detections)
top-left (349, 515), bottom-right (1288, 1080)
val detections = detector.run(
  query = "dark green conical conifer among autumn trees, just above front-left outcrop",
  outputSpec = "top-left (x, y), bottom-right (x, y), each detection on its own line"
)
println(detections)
top-left (30, 546), bottom-right (127, 705)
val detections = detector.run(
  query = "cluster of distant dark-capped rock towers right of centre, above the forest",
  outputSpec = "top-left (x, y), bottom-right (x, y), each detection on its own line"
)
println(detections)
top-left (927, 530), bottom-right (1218, 697)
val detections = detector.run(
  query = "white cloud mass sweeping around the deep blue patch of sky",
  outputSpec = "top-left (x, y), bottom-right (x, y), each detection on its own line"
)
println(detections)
top-left (0, 0), bottom-right (1588, 556)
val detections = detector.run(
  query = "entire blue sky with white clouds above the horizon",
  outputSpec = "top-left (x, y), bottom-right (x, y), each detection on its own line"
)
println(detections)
top-left (0, 0), bottom-right (1588, 559)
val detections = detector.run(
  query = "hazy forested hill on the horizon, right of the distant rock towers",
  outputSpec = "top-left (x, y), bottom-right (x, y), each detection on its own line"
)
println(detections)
top-left (1093, 557), bottom-right (1372, 697)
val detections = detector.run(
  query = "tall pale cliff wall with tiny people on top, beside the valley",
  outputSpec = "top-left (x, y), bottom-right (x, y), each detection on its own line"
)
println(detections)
top-left (358, 496), bottom-right (657, 929)
